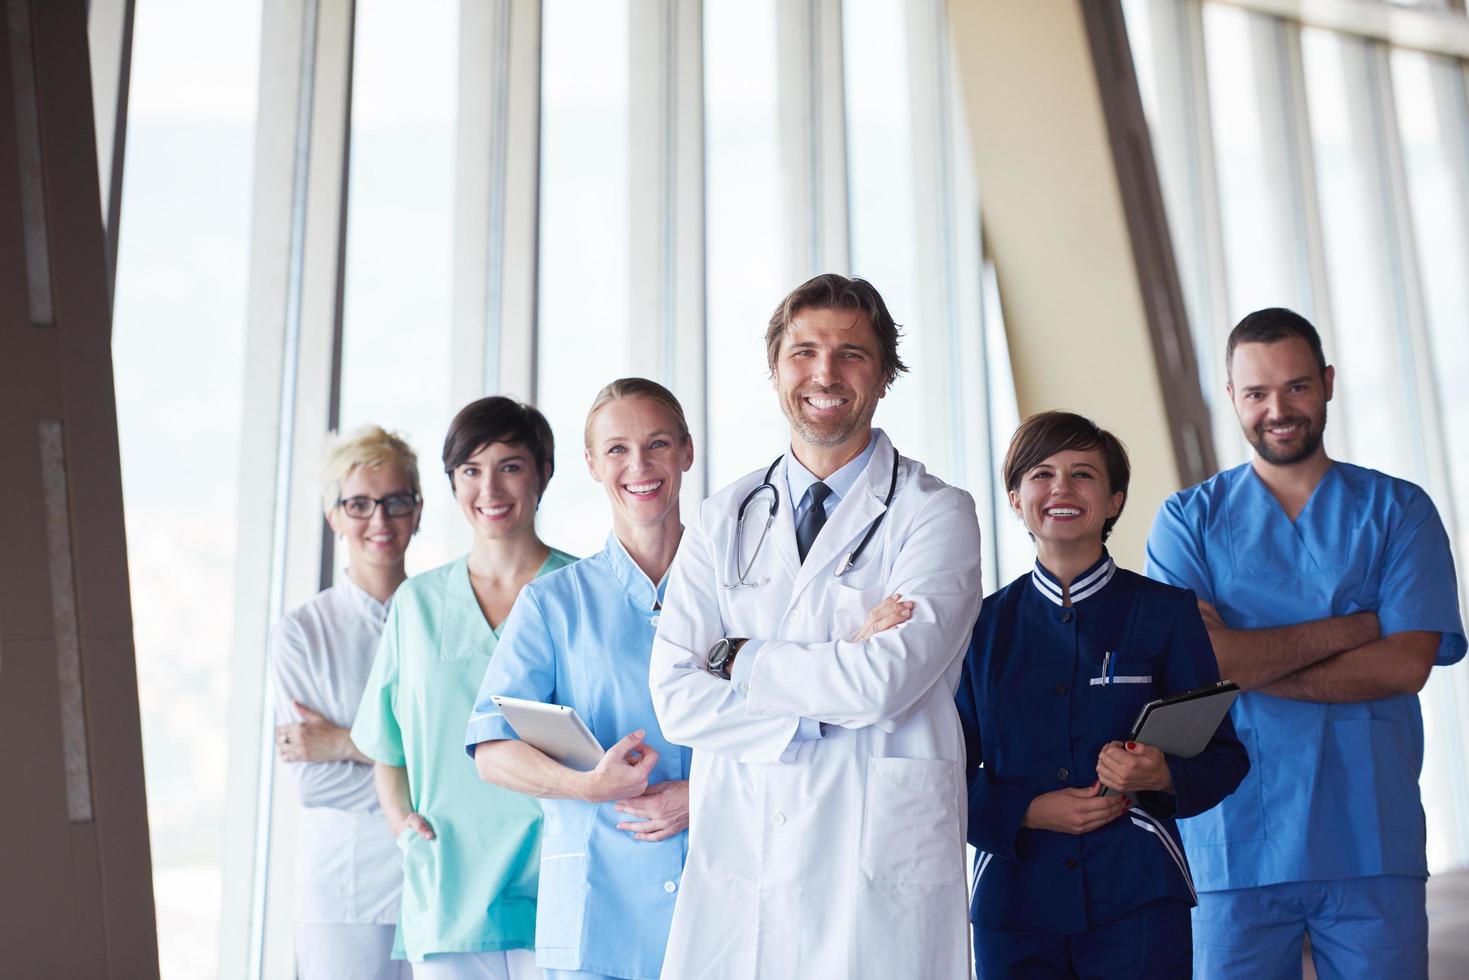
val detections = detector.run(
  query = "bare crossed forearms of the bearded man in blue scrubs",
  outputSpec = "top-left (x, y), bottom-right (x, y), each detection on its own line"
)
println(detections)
top-left (1199, 599), bottom-right (1440, 704)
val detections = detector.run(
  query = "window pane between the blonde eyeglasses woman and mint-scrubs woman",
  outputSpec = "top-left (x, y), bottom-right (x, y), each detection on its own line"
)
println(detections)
top-left (341, 0), bottom-right (463, 573)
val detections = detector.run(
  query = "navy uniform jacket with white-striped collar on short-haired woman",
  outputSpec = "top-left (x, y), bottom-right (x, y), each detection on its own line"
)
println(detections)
top-left (956, 554), bottom-right (1249, 934)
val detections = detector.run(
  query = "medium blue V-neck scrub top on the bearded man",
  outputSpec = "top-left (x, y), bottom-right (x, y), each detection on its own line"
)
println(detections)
top-left (1147, 463), bottom-right (1465, 892)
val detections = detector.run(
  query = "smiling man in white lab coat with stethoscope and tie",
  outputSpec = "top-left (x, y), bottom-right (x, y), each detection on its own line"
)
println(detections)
top-left (651, 275), bottom-right (981, 980)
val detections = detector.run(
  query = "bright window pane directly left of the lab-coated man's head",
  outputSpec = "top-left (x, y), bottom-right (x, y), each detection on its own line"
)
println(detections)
top-left (698, 0), bottom-right (796, 491)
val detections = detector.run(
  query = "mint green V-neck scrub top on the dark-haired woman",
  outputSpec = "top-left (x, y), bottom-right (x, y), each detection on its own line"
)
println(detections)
top-left (351, 548), bottom-right (576, 961)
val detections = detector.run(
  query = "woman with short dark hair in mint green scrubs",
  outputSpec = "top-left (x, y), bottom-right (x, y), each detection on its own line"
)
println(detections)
top-left (351, 397), bottom-right (574, 980)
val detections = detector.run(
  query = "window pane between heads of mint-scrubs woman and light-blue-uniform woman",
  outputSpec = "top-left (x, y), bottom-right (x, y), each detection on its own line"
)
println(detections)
top-left (536, 0), bottom-right (634, 555)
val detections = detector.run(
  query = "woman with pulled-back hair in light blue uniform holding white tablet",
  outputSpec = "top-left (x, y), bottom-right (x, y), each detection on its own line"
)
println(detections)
top-left (466, 378), bottom-right (693, 980)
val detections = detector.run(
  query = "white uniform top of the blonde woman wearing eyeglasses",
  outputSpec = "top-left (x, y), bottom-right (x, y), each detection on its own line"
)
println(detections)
top-left (270, 574), bottom-right (403, 924)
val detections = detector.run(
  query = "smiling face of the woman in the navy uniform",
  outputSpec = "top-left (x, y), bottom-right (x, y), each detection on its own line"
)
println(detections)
top-left (1009, 450), bottom-right (1124, 545)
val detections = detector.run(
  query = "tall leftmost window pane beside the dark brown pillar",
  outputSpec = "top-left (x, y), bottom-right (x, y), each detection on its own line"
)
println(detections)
top-left (112, 0), bottom-right (260, 980)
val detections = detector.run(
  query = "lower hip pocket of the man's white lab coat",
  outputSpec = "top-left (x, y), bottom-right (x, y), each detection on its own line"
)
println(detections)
top-left (862, 758), bottom-right (964, 884)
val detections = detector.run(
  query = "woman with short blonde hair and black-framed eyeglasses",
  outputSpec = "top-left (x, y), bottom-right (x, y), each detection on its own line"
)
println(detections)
top-left (270, 426), bottom-right (423, 980)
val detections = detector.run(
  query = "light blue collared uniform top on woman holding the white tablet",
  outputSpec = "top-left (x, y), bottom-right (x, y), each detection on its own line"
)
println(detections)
top-left (464, 535), bottom-right (692, 980)
